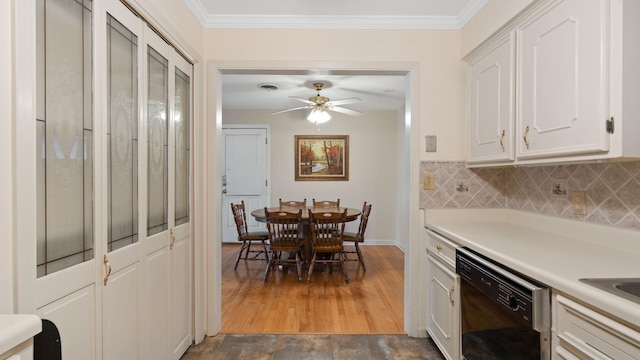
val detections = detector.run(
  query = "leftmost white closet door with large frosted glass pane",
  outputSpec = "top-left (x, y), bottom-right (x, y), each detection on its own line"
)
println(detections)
top-left (32, 0), bottom-right (97, 359)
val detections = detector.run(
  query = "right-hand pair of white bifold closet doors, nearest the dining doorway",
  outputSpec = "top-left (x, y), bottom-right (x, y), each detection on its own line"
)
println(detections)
top-left (140, 28), bottom-right (193, 359)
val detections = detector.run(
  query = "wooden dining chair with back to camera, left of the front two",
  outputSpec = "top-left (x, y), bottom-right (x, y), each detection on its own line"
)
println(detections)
top-left (264, 208), bottom-right (304, 281)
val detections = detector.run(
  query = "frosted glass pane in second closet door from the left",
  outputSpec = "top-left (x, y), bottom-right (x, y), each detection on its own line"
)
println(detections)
top-left (107, 15), bottom-right (138, 251)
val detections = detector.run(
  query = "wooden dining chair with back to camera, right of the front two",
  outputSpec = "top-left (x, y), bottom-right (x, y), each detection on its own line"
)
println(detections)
top-left (307, 209), bottom-right (349, 283)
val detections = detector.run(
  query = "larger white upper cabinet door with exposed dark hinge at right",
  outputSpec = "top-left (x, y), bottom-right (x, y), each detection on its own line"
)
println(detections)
top-left (516, 0), bottom-right (609, 158)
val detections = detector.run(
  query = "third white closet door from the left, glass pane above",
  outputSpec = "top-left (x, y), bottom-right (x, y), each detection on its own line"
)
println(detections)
top-left (140, 27), bottom-right (173, 359)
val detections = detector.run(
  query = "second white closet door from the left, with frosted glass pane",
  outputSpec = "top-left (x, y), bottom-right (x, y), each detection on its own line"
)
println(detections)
top-left (100, 0), bottom-right (143, 360)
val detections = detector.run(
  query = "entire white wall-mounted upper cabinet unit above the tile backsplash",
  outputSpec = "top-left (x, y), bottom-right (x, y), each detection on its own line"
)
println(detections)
top-left (466, 0), bottom-right (640, 166)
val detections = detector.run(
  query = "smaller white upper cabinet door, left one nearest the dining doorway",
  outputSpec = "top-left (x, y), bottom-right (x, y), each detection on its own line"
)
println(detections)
top-left (467, 32), bottom-right (515, 163)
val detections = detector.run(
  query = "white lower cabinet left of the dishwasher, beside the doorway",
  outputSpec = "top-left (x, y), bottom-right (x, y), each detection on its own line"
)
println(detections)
top-left (427, 231), bottom-right (460, 359)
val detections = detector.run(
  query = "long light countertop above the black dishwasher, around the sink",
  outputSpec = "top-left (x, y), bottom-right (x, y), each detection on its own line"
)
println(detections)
top-left (425, 209), bottom-right (640, 330)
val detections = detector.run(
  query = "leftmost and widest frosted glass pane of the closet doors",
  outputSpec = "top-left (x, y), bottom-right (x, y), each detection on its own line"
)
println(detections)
top-left (36, 0), bottom-right (93, 277)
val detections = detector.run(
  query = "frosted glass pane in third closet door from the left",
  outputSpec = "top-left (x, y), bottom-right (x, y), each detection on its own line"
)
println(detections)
top-left (147, 46), bottom-right (169, 236)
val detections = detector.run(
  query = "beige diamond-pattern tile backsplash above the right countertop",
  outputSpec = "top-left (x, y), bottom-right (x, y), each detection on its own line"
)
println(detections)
top-left (420, 161), bottom-right (640, 230)
